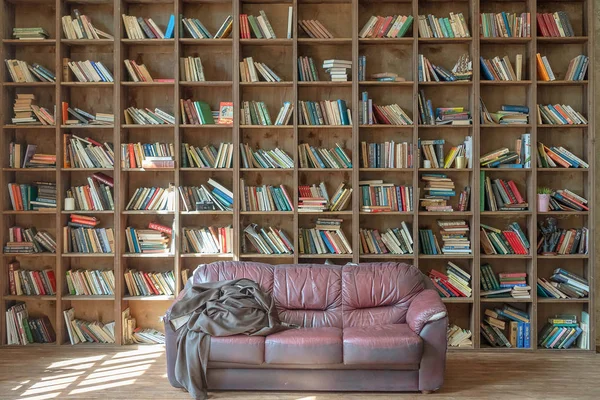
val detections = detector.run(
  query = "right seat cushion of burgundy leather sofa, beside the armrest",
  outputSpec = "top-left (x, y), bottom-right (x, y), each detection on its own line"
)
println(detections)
top-left (344, 324), bottom-right (423, 364)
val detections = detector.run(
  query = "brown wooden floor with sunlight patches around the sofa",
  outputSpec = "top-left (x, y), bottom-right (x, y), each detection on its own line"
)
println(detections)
top-left (0, 346), bottom-right (600, 400)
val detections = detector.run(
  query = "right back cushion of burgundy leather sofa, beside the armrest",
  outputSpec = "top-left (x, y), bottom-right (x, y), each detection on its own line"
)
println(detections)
top-left (342, 262), bottom-right (425, 327)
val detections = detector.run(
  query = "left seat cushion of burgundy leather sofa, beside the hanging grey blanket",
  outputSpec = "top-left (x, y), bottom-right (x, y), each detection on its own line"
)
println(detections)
top-left (208, 335), bottom-right (265, 364)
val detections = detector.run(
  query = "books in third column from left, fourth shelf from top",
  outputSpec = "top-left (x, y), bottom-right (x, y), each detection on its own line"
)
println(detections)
top-left (121, 142), bottom-right (175, 169)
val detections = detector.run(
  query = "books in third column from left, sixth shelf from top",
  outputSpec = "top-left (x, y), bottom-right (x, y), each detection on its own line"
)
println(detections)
top-left (125, 222), bottom-right (173, 254)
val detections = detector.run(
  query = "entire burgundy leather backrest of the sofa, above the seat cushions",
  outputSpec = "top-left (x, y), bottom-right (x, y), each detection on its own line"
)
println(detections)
top-left (193, 261), bottom-right (426, 328)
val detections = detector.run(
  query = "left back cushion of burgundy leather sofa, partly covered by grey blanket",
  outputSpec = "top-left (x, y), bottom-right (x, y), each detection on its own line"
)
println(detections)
top-left (193, 261), bottom-right (273, 294)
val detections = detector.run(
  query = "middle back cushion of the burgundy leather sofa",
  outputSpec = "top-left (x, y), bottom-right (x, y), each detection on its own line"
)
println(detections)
top-left (273, 264), bottom-right (342, 328)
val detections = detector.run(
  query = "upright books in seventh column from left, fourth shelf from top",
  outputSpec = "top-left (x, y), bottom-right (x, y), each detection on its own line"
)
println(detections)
top-left (360, 140), bottom-right (414, 169)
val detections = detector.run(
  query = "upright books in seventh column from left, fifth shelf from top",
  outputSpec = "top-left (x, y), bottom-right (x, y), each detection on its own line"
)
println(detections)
top-left (359, 179), bottom-right (413, 213)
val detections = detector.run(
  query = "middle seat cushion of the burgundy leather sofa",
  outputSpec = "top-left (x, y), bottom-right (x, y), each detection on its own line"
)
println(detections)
top-left (265, 327), bottom-right (342, 364)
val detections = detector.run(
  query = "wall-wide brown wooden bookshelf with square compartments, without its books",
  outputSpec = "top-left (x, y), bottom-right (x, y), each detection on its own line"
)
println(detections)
top-left (0, 0), bottom-right (596, 351)
